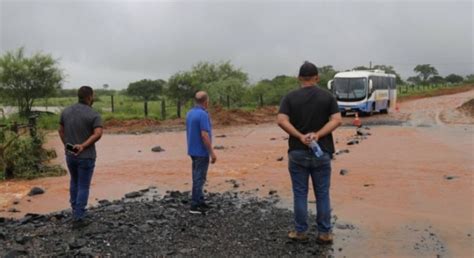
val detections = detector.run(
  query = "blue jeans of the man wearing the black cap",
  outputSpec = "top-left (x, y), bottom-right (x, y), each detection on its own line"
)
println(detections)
top-left (288, 150), bottom-right (331, 233)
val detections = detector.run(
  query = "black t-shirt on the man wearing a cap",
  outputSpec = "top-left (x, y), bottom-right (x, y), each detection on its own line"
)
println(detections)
top-left (278, 86), bottom-right (339, 154)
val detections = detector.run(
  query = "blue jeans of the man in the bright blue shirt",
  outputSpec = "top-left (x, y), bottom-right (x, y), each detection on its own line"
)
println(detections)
top-left (191, 156), bottom-right (209, 207)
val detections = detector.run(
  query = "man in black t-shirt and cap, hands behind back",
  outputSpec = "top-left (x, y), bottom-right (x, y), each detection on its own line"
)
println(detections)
top-left (278, 62), bottom-right (342, 244)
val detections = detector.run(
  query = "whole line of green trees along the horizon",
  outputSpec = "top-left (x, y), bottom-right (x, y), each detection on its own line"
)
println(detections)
top-left (0, 48), bottom-right (474, 117)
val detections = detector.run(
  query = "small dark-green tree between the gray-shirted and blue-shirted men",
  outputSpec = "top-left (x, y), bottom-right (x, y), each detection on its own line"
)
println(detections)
top-left (127, 79), bottom-right (166, 117)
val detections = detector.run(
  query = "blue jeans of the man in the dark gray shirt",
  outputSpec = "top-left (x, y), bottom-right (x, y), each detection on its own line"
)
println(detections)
top-left (66, 155), bottom-right (95, 219)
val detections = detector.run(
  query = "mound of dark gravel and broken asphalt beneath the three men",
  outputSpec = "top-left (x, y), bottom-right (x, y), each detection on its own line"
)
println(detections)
top-left (0, 188), bottom-right (336, 257)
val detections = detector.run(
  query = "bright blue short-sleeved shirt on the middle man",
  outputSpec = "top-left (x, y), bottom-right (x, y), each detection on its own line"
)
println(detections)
top-left (186, 106), bottom-right (212, 157)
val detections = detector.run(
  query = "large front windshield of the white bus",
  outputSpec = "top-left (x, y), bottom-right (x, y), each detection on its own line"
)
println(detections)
top-left (333, 78), bottom-right (367, 101)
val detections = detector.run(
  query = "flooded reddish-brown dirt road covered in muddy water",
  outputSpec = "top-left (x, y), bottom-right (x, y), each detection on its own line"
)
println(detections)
top-left (0, 91), bottom-right (474, 257)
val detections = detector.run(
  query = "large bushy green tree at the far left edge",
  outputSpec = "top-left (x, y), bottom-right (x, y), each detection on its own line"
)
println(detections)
top-left (0, 48), bottom-right (64, 116)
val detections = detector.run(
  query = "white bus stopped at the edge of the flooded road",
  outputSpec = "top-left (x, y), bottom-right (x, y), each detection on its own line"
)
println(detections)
top-left (328, 70), bottom-right (397, 115)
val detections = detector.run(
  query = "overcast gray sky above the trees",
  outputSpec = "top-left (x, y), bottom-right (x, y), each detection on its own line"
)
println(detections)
top-left (0, 0), bottom-right (474, 89)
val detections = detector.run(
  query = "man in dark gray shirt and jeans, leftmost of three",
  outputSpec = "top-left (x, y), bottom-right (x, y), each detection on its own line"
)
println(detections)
top-left (59, 86), bottom-right (102, 228)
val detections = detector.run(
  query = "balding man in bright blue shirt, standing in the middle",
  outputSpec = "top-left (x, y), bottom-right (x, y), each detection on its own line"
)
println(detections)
top-left (186, 91), bottom-right (217, 214)
